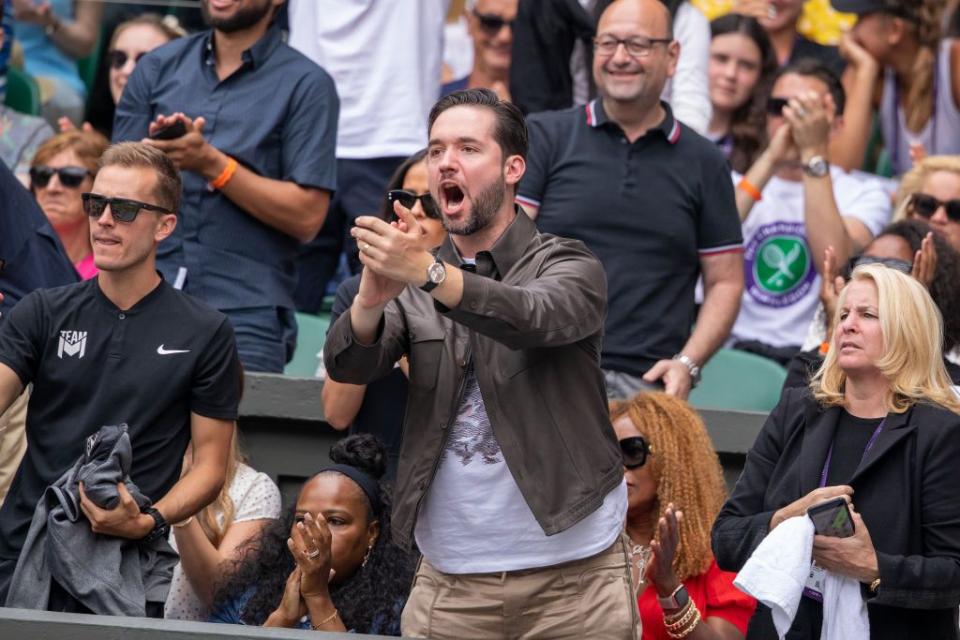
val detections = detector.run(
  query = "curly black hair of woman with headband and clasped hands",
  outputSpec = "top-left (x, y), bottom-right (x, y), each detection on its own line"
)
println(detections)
top-left (214, 434), bottom-right (416, 633)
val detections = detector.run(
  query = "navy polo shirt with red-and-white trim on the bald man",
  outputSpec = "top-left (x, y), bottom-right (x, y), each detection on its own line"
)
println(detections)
top-left (517, 99), bottom-right (743, 375)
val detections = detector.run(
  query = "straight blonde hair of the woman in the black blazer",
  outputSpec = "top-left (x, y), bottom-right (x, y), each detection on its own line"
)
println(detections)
top-left (810, 264), bottom-right (960, 413)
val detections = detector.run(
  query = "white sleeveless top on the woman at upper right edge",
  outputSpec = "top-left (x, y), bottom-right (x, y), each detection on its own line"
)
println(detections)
top-left (880, 39), bottom-right (960, 176)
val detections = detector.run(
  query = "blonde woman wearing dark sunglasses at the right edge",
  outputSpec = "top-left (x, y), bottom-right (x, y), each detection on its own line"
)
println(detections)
top-left (894, 156), bottom-right (960, 251)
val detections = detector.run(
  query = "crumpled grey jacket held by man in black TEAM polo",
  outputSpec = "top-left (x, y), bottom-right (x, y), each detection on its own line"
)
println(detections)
top-left (6, 424), bottom-right (178, 616)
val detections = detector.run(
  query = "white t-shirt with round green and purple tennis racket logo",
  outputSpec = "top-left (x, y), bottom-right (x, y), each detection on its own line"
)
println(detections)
top-left (731, 167), bottom-right (891, 347)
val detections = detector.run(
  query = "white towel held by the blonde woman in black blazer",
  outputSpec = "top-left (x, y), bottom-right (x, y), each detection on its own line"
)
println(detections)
top-left (733, 516), bottom-right (870, 640)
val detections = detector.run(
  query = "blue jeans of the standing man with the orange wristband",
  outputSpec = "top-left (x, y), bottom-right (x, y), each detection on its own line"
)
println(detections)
top-left (224, 307), bottom-right (297, 373)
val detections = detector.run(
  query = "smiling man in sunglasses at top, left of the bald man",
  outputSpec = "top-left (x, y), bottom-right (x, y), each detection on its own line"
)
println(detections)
top-left (441, 0), bottom-right (519, 100)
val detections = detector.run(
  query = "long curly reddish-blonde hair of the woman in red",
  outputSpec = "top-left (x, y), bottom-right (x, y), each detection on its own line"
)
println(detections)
top-left (610, 392), bottom-right (727, 581)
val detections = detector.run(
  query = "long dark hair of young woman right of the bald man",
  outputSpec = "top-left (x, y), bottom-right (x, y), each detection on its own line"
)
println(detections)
top-left (710, 13), bottom-right (777, 173)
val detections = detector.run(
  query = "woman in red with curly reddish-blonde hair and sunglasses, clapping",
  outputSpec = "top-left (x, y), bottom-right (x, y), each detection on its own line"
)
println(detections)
top-left (610, 392), bottom-right (756, 640)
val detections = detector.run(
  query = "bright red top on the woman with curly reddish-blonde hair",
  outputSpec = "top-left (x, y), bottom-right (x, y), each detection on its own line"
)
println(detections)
top-left (637, 560), bottom-right (757, 640)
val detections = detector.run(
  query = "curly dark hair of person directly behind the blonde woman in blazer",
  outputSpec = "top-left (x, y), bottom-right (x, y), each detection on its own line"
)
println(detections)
top-left (876, 220), bottom-right (960, 353)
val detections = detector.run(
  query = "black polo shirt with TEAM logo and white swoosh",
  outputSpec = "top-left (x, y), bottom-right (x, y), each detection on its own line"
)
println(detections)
top-left (0, 278), bottom-right (240, 564)
